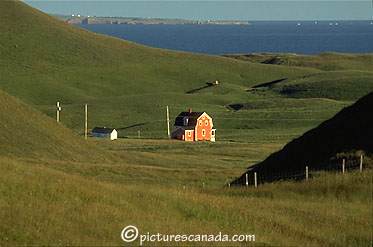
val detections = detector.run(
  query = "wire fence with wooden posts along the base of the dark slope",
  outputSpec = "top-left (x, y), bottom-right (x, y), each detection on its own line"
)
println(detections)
top-left (227, 155), bottom-right (372, 187)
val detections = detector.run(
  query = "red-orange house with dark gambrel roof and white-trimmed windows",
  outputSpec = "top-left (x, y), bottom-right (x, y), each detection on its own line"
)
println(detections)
top-left (171, 109), bottom-right (216, 142)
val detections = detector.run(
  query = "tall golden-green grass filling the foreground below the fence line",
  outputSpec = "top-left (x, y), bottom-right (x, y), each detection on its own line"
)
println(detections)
top-left (0, 158), bottom-right (373, 246)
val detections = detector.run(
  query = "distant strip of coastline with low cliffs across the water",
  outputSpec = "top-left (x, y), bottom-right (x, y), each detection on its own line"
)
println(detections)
top-left (53, 15), bottom-right (250, 25)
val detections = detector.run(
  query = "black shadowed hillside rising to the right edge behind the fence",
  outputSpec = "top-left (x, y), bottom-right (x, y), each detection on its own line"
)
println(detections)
top-left (235, 92), bottom-right (373, 183)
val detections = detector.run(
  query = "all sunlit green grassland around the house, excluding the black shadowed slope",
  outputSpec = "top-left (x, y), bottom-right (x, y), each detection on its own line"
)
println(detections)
top-left (0, 1), bottom-right (373, 246)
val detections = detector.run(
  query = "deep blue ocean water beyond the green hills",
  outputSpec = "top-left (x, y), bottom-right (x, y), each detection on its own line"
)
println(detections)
top-left (78, 21), bottom-right (373, 55)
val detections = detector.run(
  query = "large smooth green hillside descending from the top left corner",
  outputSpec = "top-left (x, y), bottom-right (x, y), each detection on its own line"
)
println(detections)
top-left (0, 1), bottom-right (315, 104)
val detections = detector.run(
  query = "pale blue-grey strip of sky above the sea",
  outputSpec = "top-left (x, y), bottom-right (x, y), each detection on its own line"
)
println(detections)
top-left (23, 0), bottom-right (373, 21)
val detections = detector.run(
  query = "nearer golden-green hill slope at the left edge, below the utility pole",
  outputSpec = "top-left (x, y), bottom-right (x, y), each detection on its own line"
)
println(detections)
top-left (0, 90), bottom-right (111, 162)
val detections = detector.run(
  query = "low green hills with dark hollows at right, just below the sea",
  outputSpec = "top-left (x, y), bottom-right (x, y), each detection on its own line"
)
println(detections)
top-left (226, 52), bottom-right (373, 100)
